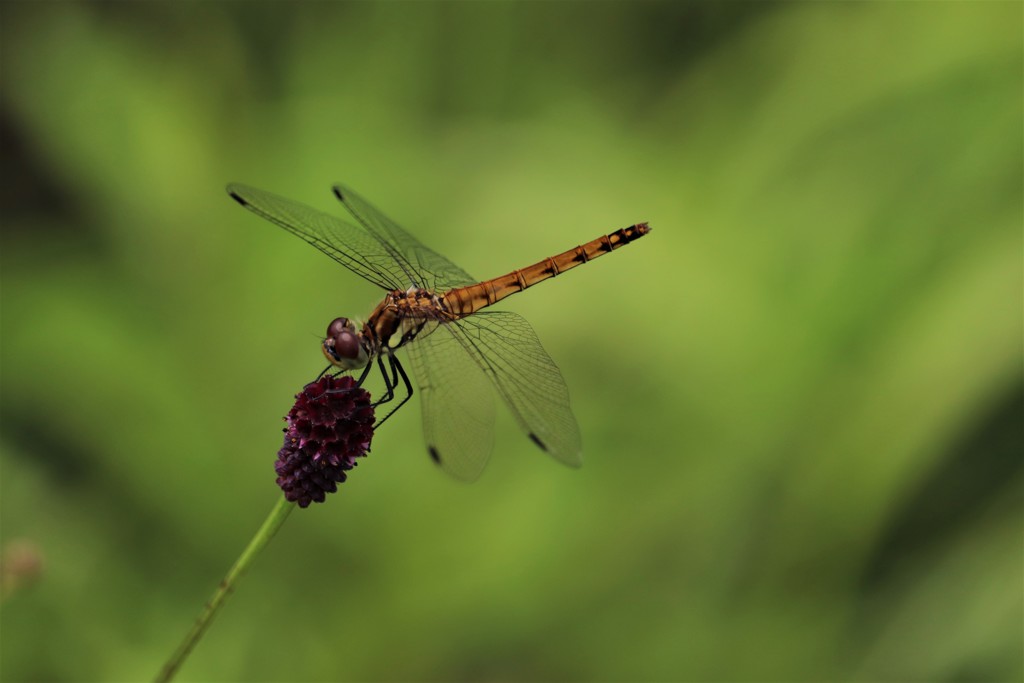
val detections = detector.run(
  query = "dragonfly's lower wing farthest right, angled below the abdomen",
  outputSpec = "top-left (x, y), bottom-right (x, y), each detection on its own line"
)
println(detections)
top-left (442, 311), bottom-right (583, 467)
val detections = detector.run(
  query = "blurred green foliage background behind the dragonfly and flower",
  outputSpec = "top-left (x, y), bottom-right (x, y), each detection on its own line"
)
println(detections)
top-left (0, 2), bottom-right (1024, 681)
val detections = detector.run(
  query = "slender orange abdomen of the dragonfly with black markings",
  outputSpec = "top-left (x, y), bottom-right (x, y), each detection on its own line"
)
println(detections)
top-left (443, 223), bottom-right (650, 317)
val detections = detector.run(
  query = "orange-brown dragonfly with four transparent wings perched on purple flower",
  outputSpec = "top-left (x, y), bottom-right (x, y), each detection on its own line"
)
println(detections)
top-left (227, 183), bottom-right (650, 480)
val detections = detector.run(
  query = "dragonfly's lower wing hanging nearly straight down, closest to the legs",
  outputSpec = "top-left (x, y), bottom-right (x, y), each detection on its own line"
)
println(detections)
top-left (404, 325), bottom-right (495, 481)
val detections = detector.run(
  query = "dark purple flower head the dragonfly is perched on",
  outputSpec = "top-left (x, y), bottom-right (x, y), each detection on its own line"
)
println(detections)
top-left (274, 375), bottom-right (374, 508)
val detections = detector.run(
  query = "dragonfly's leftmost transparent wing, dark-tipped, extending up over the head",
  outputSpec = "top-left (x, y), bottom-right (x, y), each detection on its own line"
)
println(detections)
top-left (227, 183), bottom-right (409, 290)
